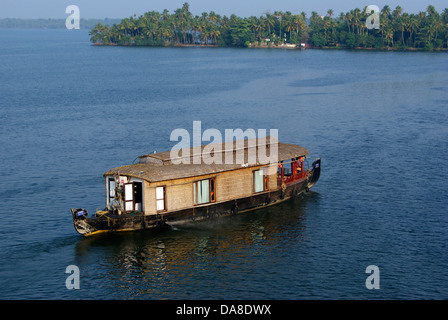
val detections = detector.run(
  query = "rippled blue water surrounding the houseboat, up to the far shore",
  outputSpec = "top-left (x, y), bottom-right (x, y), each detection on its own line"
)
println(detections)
top-left (0, 29), bottom-right (448, 300)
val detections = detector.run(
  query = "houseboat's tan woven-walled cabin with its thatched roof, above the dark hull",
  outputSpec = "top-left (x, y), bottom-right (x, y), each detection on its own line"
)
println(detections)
top-left (104, 137), bottom-right (308, 215)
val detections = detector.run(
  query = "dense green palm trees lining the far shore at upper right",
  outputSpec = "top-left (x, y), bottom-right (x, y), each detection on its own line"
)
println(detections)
top-left (89, 3), bottom-right (448, 51)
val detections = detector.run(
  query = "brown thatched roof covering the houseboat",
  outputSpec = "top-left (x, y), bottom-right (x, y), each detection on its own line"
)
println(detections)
top-left (104, 137), bottom-right (309, 182)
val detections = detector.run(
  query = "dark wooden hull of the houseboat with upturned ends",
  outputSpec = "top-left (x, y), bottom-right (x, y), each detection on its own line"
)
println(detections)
top-left (72, 159), bottom-right (320, 236)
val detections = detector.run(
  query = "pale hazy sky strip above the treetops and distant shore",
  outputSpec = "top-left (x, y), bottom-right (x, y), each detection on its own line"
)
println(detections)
top-left (0, 0), bottom-right (448, 18)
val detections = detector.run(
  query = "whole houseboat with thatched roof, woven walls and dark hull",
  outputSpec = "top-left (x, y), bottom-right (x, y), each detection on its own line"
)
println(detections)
top-left (71, 137), bottom-right (321, 236)
